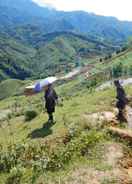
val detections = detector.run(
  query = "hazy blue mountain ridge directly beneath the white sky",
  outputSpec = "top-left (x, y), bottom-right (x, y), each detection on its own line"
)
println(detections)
top-left (0, 0), bottom-right (132, 41)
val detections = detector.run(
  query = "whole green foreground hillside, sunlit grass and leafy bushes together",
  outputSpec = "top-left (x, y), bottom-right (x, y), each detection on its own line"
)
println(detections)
top-left (0, 77), bottom-right (132, 184)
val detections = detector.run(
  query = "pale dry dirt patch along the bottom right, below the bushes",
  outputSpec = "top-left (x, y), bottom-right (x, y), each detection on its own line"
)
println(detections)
top-left (64, 143), bottom-right (132, 184)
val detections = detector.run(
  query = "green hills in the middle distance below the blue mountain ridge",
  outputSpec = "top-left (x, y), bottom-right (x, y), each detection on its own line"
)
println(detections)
top-left (0, 32), bottom-right (115, 80)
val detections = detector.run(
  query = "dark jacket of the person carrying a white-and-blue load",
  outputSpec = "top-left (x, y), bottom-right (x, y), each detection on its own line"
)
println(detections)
top-left (45, 88), bottom-right (58, 113)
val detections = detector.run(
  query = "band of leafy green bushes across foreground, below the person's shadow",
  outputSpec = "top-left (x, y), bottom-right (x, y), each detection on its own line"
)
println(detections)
top-left (0, 128), bottom-right (105, 184)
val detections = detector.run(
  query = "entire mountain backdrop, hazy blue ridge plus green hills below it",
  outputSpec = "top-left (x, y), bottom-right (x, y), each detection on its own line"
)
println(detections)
top-left (0, 0), bottom-right (132, 80)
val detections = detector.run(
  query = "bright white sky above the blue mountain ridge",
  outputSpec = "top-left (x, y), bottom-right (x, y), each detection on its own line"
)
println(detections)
top-left (33, 0), bottom-right (132, 21)
